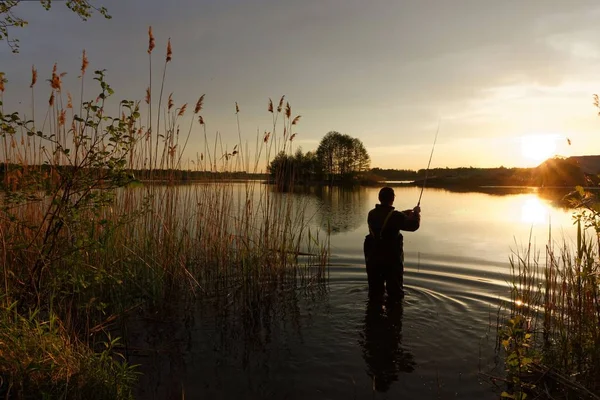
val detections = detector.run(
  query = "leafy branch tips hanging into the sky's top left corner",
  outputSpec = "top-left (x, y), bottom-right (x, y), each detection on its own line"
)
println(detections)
top-left (0, 0), bottom-right (111, 53)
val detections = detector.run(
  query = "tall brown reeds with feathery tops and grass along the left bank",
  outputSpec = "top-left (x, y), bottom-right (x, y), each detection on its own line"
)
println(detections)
top-left (0, 30), bottom-right (328, 398)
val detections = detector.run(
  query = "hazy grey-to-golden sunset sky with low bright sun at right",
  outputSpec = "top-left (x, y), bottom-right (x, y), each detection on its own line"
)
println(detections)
top-left (0, 0), bottom-right (600, 169)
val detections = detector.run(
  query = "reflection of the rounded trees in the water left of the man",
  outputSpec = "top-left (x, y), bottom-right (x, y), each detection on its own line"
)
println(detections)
top-left (296, 186), bottom-right (368, 235)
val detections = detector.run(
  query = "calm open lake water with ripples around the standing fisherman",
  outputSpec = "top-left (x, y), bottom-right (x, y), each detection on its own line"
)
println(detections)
top-left (132, 187), bottom-right (574, 399)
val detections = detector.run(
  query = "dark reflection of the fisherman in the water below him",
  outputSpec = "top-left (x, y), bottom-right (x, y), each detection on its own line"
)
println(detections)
top-left (360, 298), bottom-right (416, 392)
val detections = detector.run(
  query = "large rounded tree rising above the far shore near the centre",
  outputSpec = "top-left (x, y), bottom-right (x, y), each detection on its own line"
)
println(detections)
top-left (317, 131), bottom-right (371, 182)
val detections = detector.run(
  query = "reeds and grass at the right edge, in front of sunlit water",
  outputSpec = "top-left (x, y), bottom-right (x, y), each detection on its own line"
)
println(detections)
top-left (498, 195), bottom-right (600, 399)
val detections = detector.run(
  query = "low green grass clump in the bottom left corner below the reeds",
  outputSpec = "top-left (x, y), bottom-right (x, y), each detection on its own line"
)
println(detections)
top-left (0, 303), bottom-right (137, 399)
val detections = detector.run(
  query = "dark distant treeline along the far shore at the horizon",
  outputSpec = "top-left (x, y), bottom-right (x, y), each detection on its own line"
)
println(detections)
top-left (0, 153), bottom-right (600, 187)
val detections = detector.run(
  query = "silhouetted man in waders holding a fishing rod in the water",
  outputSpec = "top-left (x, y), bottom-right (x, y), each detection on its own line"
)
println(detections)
top-left (364, 187), bottom-right (421, 297)
